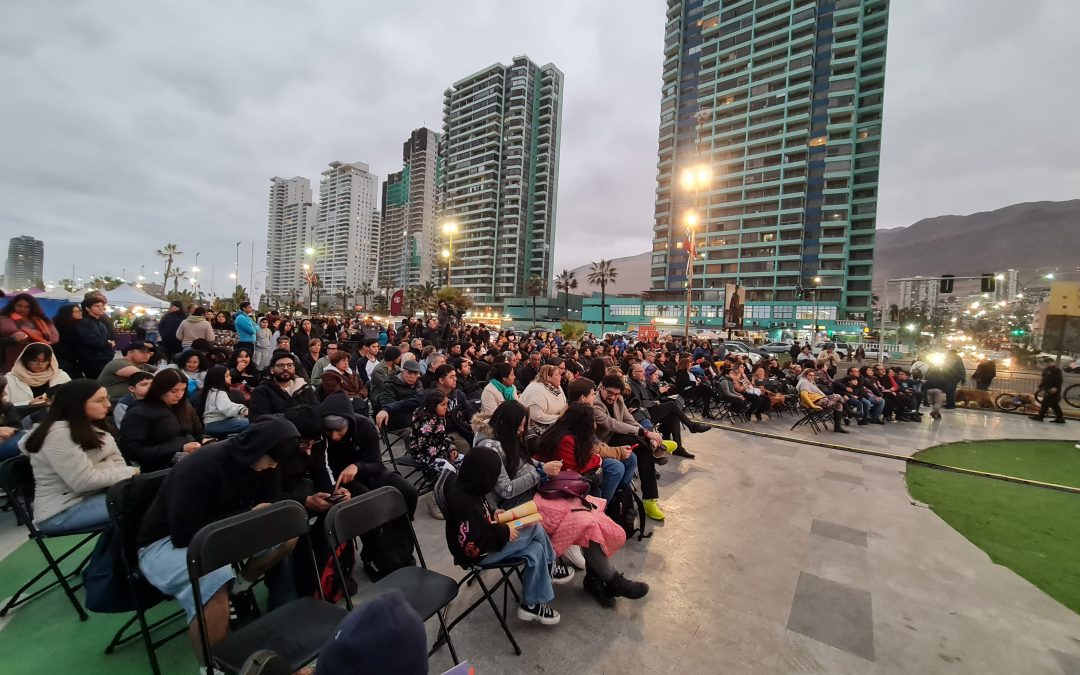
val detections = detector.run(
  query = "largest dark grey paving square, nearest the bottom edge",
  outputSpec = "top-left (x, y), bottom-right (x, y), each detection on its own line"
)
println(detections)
top-left (787, 572), bottom-right (874, 661)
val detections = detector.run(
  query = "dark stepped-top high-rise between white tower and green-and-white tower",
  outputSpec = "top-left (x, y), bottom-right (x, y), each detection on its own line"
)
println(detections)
top-left (378, 127), bottom-right (442, 287)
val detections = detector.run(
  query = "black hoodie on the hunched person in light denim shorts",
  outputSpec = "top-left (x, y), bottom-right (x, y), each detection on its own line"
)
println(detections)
top-left (138, 417), bottom-right (299, 549)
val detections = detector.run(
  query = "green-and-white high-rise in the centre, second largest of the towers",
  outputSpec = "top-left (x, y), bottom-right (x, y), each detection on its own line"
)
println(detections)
top-left (438, 56), bottom-right (563, 305)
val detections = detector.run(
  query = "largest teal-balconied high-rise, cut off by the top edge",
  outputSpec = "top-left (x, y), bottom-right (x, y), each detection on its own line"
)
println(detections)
top-left (651, 0), bottom-right (889, 327)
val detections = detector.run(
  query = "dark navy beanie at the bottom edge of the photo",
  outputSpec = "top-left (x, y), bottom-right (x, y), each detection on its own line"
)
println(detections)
top-left (315, 589), bottom-right (428, 675)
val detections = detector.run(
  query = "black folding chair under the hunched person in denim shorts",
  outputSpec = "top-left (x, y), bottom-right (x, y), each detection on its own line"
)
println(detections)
top-left (105, 470), bottom-right (188, 675)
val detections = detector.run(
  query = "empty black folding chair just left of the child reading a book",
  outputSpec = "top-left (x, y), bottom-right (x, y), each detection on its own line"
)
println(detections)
top-left (325, 486), bottom-right (459, 664)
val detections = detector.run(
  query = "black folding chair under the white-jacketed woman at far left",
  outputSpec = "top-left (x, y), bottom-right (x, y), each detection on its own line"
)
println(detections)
top-left (0, 456), bottom-right (105, 621)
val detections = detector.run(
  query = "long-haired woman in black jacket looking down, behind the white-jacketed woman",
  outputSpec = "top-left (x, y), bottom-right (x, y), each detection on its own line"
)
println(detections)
top-left (120, 368), bottom-right (203, 471)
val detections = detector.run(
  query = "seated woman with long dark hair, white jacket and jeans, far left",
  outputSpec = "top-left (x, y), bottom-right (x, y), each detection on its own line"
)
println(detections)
top-left (23, 379), bottom-right (138, 535)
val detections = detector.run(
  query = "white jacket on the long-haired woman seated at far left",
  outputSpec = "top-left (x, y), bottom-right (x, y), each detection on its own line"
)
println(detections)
top-left (19, 422), bottom-right (136, 525)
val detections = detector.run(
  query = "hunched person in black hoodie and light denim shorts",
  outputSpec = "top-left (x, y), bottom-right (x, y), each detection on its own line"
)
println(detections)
top-left (136, 419), bottom-right (300, 656)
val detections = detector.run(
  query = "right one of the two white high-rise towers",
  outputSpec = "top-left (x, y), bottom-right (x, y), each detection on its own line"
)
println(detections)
top-left (315, 162), bottom-right (380, 297)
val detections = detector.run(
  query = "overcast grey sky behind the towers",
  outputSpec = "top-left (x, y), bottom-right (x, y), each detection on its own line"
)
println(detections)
top-left (0, 0), bottom-right (1080, 289)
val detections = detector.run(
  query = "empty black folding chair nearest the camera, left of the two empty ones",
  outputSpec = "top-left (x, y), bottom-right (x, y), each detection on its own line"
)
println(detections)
top-left (188, 501), bottom-right (346, 673)
